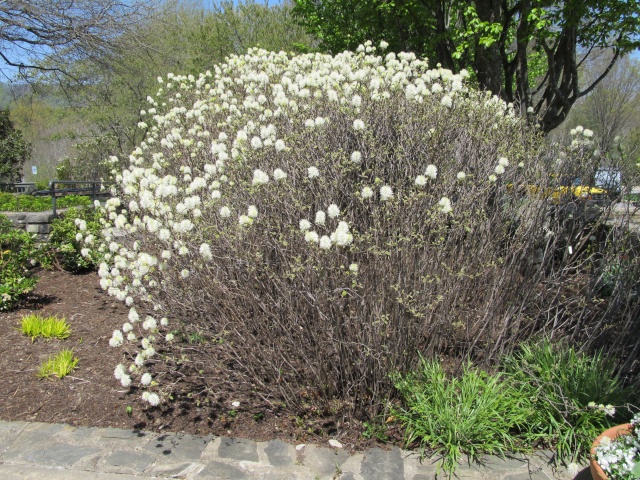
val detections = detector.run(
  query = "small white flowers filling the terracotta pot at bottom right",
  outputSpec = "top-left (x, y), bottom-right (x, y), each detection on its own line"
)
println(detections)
top-left (595, 413), bottom-right (640, 480)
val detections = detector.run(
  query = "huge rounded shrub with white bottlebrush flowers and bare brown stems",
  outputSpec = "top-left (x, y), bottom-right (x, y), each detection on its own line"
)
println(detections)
top-left (99, 45), bottom-right (628, 414)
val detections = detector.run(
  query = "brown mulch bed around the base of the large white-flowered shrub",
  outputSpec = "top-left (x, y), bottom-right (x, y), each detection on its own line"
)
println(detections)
top-left (0, 270), bottom-right (401, 450)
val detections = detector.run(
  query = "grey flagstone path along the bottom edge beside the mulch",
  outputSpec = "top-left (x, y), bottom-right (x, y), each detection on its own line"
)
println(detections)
top-left (0, 422), bottom-right (591, 480)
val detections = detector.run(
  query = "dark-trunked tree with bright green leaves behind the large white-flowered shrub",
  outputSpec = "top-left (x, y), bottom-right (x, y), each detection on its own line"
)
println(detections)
top-left (294, 0), bottom-right (640, 132)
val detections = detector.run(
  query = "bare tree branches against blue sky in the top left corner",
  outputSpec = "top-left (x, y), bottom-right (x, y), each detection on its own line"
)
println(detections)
top-left (0, 0), bottom-right (157, 77)
